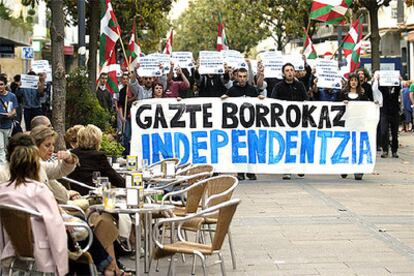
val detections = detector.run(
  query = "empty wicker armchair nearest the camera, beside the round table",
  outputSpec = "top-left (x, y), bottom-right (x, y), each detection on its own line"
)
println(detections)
top-left (153, 199), bottom-right (240, 275)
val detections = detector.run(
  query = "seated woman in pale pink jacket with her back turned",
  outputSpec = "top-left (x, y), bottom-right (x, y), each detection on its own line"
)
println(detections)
top-left (0, 145), bottom-right (69, 275)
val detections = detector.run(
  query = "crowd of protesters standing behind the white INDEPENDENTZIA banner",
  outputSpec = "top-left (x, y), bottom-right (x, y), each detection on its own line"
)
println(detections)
top-left (96, 56), bottom-right (414, 180)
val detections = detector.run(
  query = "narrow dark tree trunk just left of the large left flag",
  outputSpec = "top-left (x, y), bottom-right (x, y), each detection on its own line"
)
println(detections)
top-left (88, 0), bottom-right (101, 91)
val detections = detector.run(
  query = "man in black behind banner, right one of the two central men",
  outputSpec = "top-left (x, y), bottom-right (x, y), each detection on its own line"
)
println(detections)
top-left (270, 63), bottom-right (308, 180)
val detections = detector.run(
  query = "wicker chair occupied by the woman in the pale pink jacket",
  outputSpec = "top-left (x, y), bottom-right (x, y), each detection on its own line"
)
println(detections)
top-left (0, 204), bottom-right (97, 275)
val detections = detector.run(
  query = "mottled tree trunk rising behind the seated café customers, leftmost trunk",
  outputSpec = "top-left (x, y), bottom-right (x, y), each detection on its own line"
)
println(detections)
top-left (50, 0), bottom-right (66, 150)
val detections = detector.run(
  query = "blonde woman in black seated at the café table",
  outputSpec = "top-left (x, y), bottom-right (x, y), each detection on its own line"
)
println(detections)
top-left (68, 125), bottom-right (125, 195)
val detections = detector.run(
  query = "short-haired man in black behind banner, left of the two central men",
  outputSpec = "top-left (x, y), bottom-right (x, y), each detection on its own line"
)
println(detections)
top-left (221, 68), bottom-right (264, 180)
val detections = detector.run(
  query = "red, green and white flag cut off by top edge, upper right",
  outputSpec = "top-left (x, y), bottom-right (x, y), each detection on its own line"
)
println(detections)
top-left (310, 0), bottom-right (352, 24)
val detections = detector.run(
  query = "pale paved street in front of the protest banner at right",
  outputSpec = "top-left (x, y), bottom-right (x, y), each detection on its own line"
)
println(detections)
top-left (123, 134), bottom-right (414, 275)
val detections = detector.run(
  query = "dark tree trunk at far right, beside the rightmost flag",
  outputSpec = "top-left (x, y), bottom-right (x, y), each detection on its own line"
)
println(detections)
top-left (368, 4), bottom-right (381, 73)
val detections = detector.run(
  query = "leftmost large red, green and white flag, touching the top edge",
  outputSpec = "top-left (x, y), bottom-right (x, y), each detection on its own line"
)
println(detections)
top-left (99, 0), bottom-right (121, 66)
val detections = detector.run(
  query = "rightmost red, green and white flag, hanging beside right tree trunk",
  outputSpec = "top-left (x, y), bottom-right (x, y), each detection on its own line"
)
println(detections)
top-left (342, 20), bottom-right (362, 73)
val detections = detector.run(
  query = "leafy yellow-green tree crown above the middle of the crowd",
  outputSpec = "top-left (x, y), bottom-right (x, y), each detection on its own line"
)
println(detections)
top-left (173, 0), bottom-right (270, 53)
